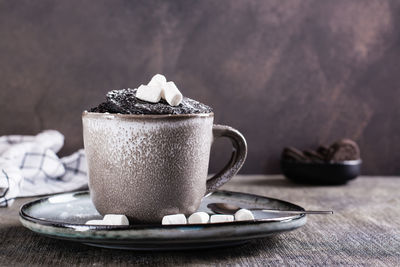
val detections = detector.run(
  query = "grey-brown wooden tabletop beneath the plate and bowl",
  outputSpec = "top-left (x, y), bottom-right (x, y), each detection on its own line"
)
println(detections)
top-left (0, 175), bottom-right (400, 266)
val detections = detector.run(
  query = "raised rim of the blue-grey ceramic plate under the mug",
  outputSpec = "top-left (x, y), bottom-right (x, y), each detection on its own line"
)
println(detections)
top-left (20, 190), bottom-right (307, 245)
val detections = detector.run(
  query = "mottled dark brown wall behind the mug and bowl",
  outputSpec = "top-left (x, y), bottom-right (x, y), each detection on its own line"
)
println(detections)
top-left (0, 0), bottom-right (400, 174)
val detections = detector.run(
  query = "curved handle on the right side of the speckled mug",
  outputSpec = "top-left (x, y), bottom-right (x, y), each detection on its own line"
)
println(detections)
top-left (206, 124), bottom-right (247, 194)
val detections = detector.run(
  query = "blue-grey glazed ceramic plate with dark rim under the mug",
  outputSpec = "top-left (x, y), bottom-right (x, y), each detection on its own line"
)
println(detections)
top-left (20, 191), bottom-right (306, 250)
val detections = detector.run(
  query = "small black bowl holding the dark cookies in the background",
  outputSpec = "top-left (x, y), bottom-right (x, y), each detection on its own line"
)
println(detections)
top-left (281, 160), bottom-right (362, 185)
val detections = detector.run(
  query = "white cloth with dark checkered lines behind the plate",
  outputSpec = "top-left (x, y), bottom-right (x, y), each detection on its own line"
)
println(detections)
top-left (0, 130), bottom-right (88, 207)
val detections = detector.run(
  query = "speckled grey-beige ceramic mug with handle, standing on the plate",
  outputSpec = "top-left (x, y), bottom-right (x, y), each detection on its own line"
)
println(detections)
top-left (82, 111), bottom-right (247, 223)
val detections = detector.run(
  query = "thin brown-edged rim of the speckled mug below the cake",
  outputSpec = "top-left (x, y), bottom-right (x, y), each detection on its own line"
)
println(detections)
top-left (82, 110), bottom-right (214, 119)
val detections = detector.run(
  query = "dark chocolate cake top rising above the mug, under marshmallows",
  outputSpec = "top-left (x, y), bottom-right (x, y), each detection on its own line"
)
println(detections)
top-left (89, 88), bottom-right (212, 115)
